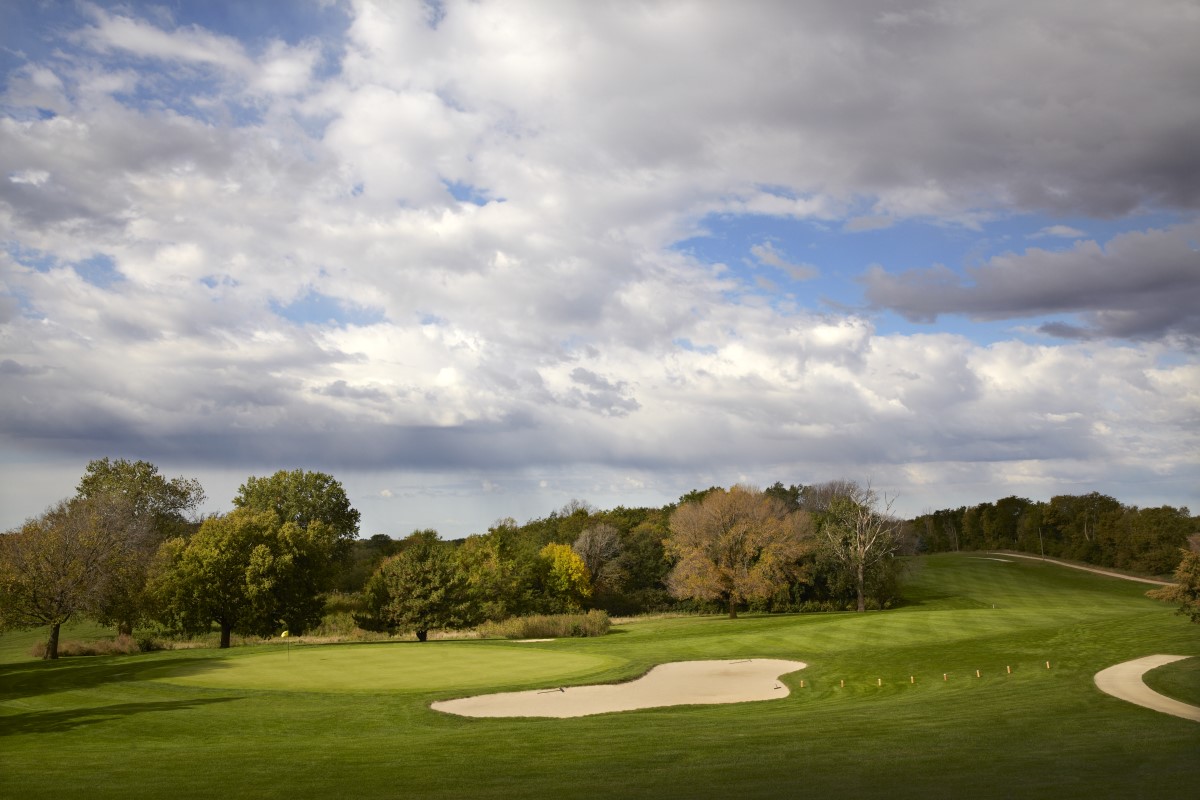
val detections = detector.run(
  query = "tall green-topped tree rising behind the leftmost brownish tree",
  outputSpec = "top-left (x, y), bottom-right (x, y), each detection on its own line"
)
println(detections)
top-left (76, 458), bottom-right (205, 634)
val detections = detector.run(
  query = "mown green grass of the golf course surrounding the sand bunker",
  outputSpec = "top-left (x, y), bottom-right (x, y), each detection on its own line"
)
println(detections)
top-left (0, 554), bottom-right (1200, 800)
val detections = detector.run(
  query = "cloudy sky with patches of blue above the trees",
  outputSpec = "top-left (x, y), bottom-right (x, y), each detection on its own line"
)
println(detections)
top-left (0, 0), bottom-right (1200, 537)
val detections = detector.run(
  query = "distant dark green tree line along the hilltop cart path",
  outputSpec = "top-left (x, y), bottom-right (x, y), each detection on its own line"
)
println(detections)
top-left (910, 492), bottom-right (1200, 575)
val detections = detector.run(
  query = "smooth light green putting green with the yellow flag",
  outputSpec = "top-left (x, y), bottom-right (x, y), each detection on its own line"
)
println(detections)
top-left (156, 642), bottom-right (625, 693)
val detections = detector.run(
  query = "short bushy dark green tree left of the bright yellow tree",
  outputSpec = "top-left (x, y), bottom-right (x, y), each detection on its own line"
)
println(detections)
top-left (367, 530), bottom-right (473, 642)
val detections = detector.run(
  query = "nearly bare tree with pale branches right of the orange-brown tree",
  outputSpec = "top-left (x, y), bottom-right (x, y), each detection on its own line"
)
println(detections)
top-left (820, 481), bottom-right (900, 612)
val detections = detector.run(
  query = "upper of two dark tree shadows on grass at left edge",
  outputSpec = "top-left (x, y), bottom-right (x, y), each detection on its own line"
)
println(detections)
top-left (0, 656), bottom-right (224, 700)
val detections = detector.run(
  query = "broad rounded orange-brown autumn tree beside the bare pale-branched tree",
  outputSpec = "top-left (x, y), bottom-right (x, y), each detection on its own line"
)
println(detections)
top-left (666, 486), bottom-right (812, 619)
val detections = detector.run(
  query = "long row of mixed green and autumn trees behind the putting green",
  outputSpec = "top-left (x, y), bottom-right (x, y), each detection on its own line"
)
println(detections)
top-left (0, 458), bottom-right (901, 658)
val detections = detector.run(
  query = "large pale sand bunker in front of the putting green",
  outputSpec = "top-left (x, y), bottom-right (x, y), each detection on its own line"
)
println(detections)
top-left (433, 658), bottom-right (808, 717)
